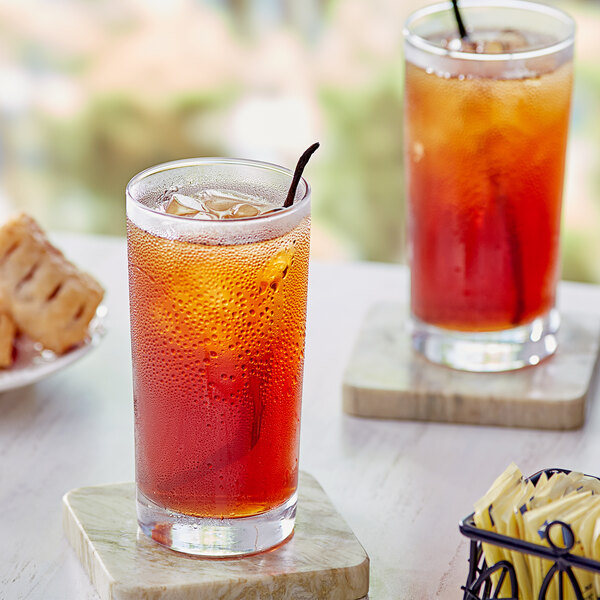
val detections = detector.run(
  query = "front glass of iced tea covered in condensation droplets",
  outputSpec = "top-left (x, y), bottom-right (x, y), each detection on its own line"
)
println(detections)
top-left (127, 158), bottom-right (310, 556)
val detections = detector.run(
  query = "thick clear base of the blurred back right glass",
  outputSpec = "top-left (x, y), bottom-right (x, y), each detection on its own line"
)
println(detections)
top-left (411, 309), bottom-right (560, 373)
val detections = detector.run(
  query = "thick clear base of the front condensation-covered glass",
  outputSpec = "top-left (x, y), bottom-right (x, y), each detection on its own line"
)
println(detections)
top-left (137, 490), bottom-right (298, 558)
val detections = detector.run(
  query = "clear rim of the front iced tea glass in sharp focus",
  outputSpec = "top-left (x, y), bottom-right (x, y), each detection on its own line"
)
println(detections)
top-left (125, 156), bottom-right (311, 227)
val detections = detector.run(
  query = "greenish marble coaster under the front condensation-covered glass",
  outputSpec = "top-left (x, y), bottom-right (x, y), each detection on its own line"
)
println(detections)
top-left (63, 472), bottom-right (369, 600)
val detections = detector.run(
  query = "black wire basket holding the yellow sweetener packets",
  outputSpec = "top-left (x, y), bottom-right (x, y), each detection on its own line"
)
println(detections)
top-left (458, 469), bottom-right (600, 600)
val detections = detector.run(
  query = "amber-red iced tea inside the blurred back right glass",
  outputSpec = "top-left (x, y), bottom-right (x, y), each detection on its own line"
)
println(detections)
top-left (405, 63), bottom-right (572, 331)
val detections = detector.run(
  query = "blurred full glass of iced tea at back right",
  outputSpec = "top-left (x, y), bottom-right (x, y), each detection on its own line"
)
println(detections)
top-left (404, 0), bottom-right (574, 371)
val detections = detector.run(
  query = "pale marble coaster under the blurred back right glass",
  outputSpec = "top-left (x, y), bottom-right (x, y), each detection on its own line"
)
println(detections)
top-left (343, 304), bottom-right (600, 429)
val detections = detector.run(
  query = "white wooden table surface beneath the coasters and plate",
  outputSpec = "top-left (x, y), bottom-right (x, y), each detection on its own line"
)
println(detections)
top-left (0, 234), bottom-right (600, 600)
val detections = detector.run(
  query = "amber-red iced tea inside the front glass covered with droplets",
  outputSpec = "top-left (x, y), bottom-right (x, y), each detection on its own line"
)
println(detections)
top-left (128, 218), bottom-right (310, 518)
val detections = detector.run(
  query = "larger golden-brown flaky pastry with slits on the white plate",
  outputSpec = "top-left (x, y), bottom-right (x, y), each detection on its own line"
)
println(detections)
top-left (0, 215), bottom-right (103, 354)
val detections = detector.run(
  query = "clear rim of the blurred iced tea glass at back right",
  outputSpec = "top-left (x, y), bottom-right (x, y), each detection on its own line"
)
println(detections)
top-left (402, 0), bottom-right (575, 62)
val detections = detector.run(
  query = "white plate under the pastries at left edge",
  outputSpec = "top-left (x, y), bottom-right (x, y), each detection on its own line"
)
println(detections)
top-left (0, 304), bottom-right (108, 392)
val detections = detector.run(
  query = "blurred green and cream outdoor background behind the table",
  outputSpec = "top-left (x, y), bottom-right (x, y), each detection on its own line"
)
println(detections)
top-left (0, 0), bottom-right (600, 282)
